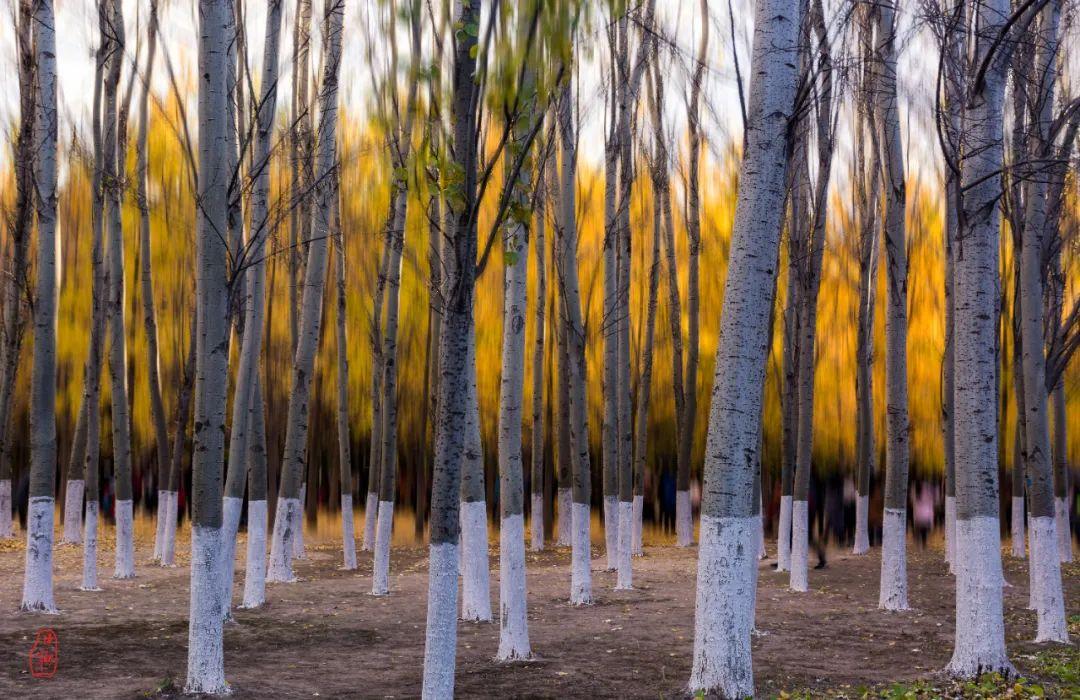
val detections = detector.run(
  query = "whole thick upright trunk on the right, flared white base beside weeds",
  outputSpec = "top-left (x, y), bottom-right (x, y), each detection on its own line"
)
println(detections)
top-left (947, 0), bottom-right (1013, 677)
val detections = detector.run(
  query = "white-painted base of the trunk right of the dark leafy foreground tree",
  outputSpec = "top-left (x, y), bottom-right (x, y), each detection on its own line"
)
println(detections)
top-left (495, 513), bottom-right (532, 661)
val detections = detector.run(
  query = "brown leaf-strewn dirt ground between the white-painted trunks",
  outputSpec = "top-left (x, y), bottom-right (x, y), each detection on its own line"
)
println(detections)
top-left (0, 519), bottom-right (1080, 698)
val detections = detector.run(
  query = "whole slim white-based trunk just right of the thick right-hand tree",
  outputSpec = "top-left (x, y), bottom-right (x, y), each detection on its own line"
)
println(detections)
top-left (1020, 0), bottom-right (1069, 642)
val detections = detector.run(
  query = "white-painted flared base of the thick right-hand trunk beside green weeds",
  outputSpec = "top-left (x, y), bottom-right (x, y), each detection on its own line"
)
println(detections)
top-left (946, 515), bottom-right (1016, 678)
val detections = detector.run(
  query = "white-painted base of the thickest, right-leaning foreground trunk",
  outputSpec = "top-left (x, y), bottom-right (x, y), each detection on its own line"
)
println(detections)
top-left (689, 514), bottom-right (758, 698)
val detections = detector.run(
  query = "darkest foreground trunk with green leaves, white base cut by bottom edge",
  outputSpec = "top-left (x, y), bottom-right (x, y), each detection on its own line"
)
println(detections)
top-left (422, 0), bottom-right (484, 700)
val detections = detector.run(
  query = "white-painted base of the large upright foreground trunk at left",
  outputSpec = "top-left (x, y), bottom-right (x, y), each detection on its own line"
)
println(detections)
top-left (184, 525), bottom-right (229, 695)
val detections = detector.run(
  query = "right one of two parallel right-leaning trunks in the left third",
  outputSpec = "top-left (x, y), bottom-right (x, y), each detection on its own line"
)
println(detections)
top-left (267, 0), bottom-right (345, 581)
